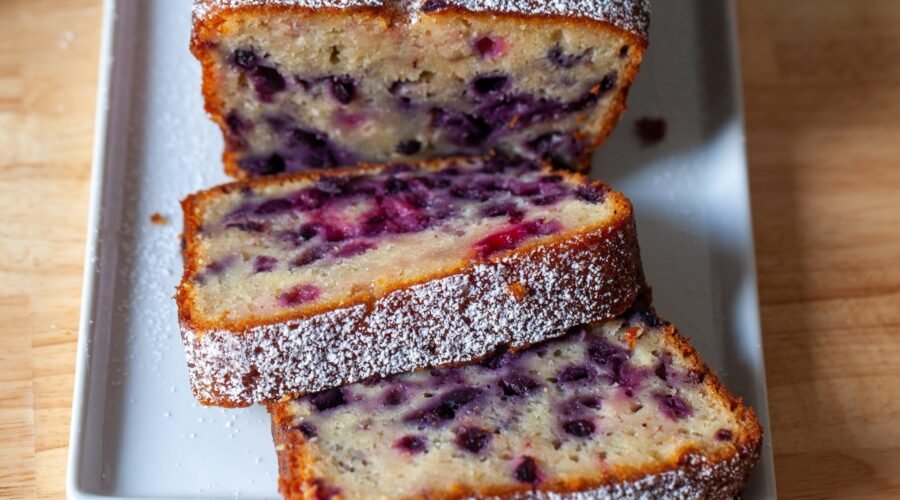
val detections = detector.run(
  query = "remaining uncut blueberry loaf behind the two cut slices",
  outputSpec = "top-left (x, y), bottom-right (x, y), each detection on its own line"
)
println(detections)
top-left (192, 0), bottom-right (649, 177)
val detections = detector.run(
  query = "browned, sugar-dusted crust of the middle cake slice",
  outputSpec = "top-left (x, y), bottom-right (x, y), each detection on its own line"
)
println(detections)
top-left (176, 160), bottom-right (646, 407)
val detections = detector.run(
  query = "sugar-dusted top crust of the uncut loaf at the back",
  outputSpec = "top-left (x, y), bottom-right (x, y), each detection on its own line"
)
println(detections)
top-left (194, 0), bottom-right (650, 38)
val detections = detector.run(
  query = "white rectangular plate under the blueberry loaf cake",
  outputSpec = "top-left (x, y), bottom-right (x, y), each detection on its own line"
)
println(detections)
top-left (68, 0), bottom-right (775, 498)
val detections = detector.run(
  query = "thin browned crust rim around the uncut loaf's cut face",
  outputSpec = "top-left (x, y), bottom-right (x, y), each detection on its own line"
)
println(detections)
top-left (190, 4), bottom-right (648, 179)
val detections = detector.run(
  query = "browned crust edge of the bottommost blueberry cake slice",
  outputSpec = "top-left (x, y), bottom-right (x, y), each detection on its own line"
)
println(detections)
top-left (268, 316), bottom-right (763, 500)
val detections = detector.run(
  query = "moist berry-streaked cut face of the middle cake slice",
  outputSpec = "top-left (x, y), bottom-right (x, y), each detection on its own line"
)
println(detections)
top-left (185, 157), bottom-right (615, 322)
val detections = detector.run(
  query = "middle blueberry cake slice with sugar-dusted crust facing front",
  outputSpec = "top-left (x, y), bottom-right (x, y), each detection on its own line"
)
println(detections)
top-left (176, 156), bottom-right (645, 406)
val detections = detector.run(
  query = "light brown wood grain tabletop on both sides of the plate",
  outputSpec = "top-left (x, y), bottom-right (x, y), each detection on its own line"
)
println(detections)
top-left (0, 0), bottom-right (900, 498)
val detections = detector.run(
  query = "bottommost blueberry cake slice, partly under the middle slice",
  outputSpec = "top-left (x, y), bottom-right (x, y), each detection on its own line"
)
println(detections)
top-left (269, 313), bottom-right (762, 499)
